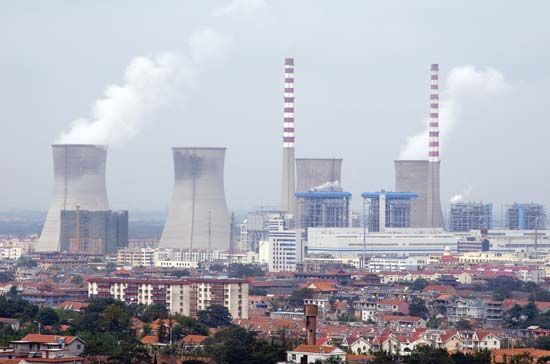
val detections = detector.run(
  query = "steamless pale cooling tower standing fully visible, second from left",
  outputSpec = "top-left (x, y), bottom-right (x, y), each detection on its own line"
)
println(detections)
top-left (159, 148), bottom-right (230, 250)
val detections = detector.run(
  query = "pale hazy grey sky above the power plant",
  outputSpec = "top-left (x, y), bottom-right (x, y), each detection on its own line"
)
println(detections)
top-left (0, 0), bottom-right (550, 216)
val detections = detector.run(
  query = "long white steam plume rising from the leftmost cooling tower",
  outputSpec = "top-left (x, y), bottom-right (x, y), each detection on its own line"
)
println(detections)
top-left (56, 0), bottom-right (252, 145)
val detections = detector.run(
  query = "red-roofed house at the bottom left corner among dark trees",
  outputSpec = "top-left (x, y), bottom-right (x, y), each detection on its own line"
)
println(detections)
top-left (9, 334), bottom-right (86, 356)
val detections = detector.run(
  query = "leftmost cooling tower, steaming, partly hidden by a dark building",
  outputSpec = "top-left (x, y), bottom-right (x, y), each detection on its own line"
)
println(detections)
top-left (36, 144), bottom-right (109, 251)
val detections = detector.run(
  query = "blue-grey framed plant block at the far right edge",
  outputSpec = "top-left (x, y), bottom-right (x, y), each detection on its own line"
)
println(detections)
top-left (506, 203), bottom-right (546, 230)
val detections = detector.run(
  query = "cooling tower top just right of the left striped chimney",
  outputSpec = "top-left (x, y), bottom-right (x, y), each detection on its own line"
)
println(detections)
top-left (296, 158), bottom-right (342, 192)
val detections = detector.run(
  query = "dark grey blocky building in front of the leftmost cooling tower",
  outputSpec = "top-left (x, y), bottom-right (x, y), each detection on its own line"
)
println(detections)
top-left (60, 206), bottom-right (128, 254)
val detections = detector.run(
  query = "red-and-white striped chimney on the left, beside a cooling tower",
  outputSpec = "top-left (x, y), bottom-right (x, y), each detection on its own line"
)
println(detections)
top-left (281, 58), bottom-right (296, 213)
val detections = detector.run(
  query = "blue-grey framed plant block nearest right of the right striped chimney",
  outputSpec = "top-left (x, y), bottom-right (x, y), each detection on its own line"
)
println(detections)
top-left (449, 201), bottom-right (493, 231)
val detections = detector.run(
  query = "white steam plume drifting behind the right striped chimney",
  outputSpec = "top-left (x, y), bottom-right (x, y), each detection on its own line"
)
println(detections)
top-left (399, 65), bottom-right (510, 159)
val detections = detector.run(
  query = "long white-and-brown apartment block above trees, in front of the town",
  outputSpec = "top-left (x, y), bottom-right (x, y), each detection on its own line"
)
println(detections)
top-left (88, 277), bottom-right (248, 319)
